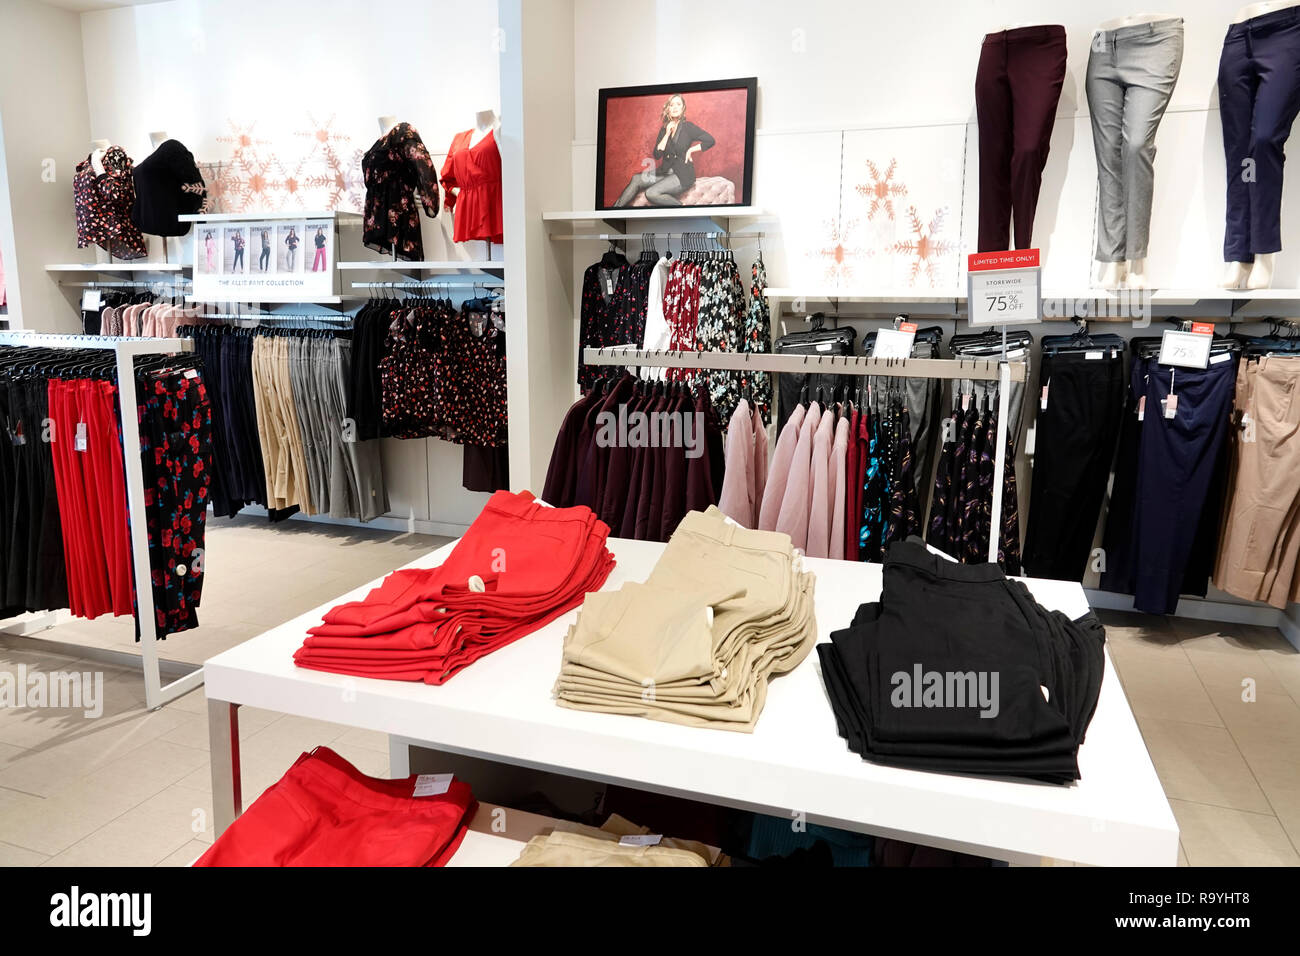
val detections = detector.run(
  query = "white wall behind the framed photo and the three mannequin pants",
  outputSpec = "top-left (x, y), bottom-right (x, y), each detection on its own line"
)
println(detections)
top-left (573, 0), bottom-right (1300, 289)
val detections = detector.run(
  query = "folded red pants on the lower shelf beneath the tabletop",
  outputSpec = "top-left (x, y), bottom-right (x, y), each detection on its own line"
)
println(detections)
top-left (195, 747), bottom-right (478, 866)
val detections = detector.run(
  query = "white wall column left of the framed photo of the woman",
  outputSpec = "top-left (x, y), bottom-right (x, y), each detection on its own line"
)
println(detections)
top-left (497, 0), bottom-right (577, 494)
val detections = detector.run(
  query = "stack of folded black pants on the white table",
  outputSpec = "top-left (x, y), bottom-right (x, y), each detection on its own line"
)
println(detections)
top-left (816, 540), bottom-right (1105, 783)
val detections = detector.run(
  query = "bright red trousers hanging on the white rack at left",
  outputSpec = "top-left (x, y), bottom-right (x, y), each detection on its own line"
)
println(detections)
top-left (42, 378), bottom-right (133, 618)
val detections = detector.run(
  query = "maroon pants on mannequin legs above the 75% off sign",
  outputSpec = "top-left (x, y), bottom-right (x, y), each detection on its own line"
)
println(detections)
top-left (975, 26), bottom-right (1066, 252)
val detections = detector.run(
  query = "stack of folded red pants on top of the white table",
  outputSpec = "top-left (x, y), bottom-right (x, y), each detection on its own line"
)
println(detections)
top-left (294, 492), bottom-right (614, 684)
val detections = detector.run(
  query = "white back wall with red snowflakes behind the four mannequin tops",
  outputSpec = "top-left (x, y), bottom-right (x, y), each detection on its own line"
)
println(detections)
top-left (74, 0), bottom-right (501, 528)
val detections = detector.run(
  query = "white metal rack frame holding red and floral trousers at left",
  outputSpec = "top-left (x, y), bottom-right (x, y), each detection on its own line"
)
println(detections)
top-left (0, 332), bottom-right (203, 710)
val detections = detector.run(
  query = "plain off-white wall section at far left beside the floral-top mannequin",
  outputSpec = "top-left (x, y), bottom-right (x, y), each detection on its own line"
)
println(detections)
top-left (0, 0), bottom-right (90, 332)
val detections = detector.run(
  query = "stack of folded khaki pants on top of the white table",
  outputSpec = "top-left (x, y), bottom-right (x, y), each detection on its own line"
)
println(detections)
top-left (555, 507), bottom-right (816, 732)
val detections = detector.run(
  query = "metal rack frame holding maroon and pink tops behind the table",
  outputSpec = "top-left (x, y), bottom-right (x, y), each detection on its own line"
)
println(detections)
top-left (582, 345), bottom-right (1026, 564)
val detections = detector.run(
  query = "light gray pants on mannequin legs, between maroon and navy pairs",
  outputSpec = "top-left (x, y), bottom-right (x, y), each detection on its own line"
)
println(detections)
top-left (1086, 20), bottom-right (1183, 263)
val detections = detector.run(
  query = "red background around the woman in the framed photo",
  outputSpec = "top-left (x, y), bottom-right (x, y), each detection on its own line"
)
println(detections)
top-left (602, 90), bottom-right (749, 206)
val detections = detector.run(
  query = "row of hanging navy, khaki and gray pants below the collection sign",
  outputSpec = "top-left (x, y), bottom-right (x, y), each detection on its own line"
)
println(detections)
top-left (179, 325), bottom-right (389, 522)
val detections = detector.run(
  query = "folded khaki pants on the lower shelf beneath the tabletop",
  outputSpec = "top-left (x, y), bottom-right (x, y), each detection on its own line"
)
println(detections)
top-left (511, 814), bottom-right (731, 866)
